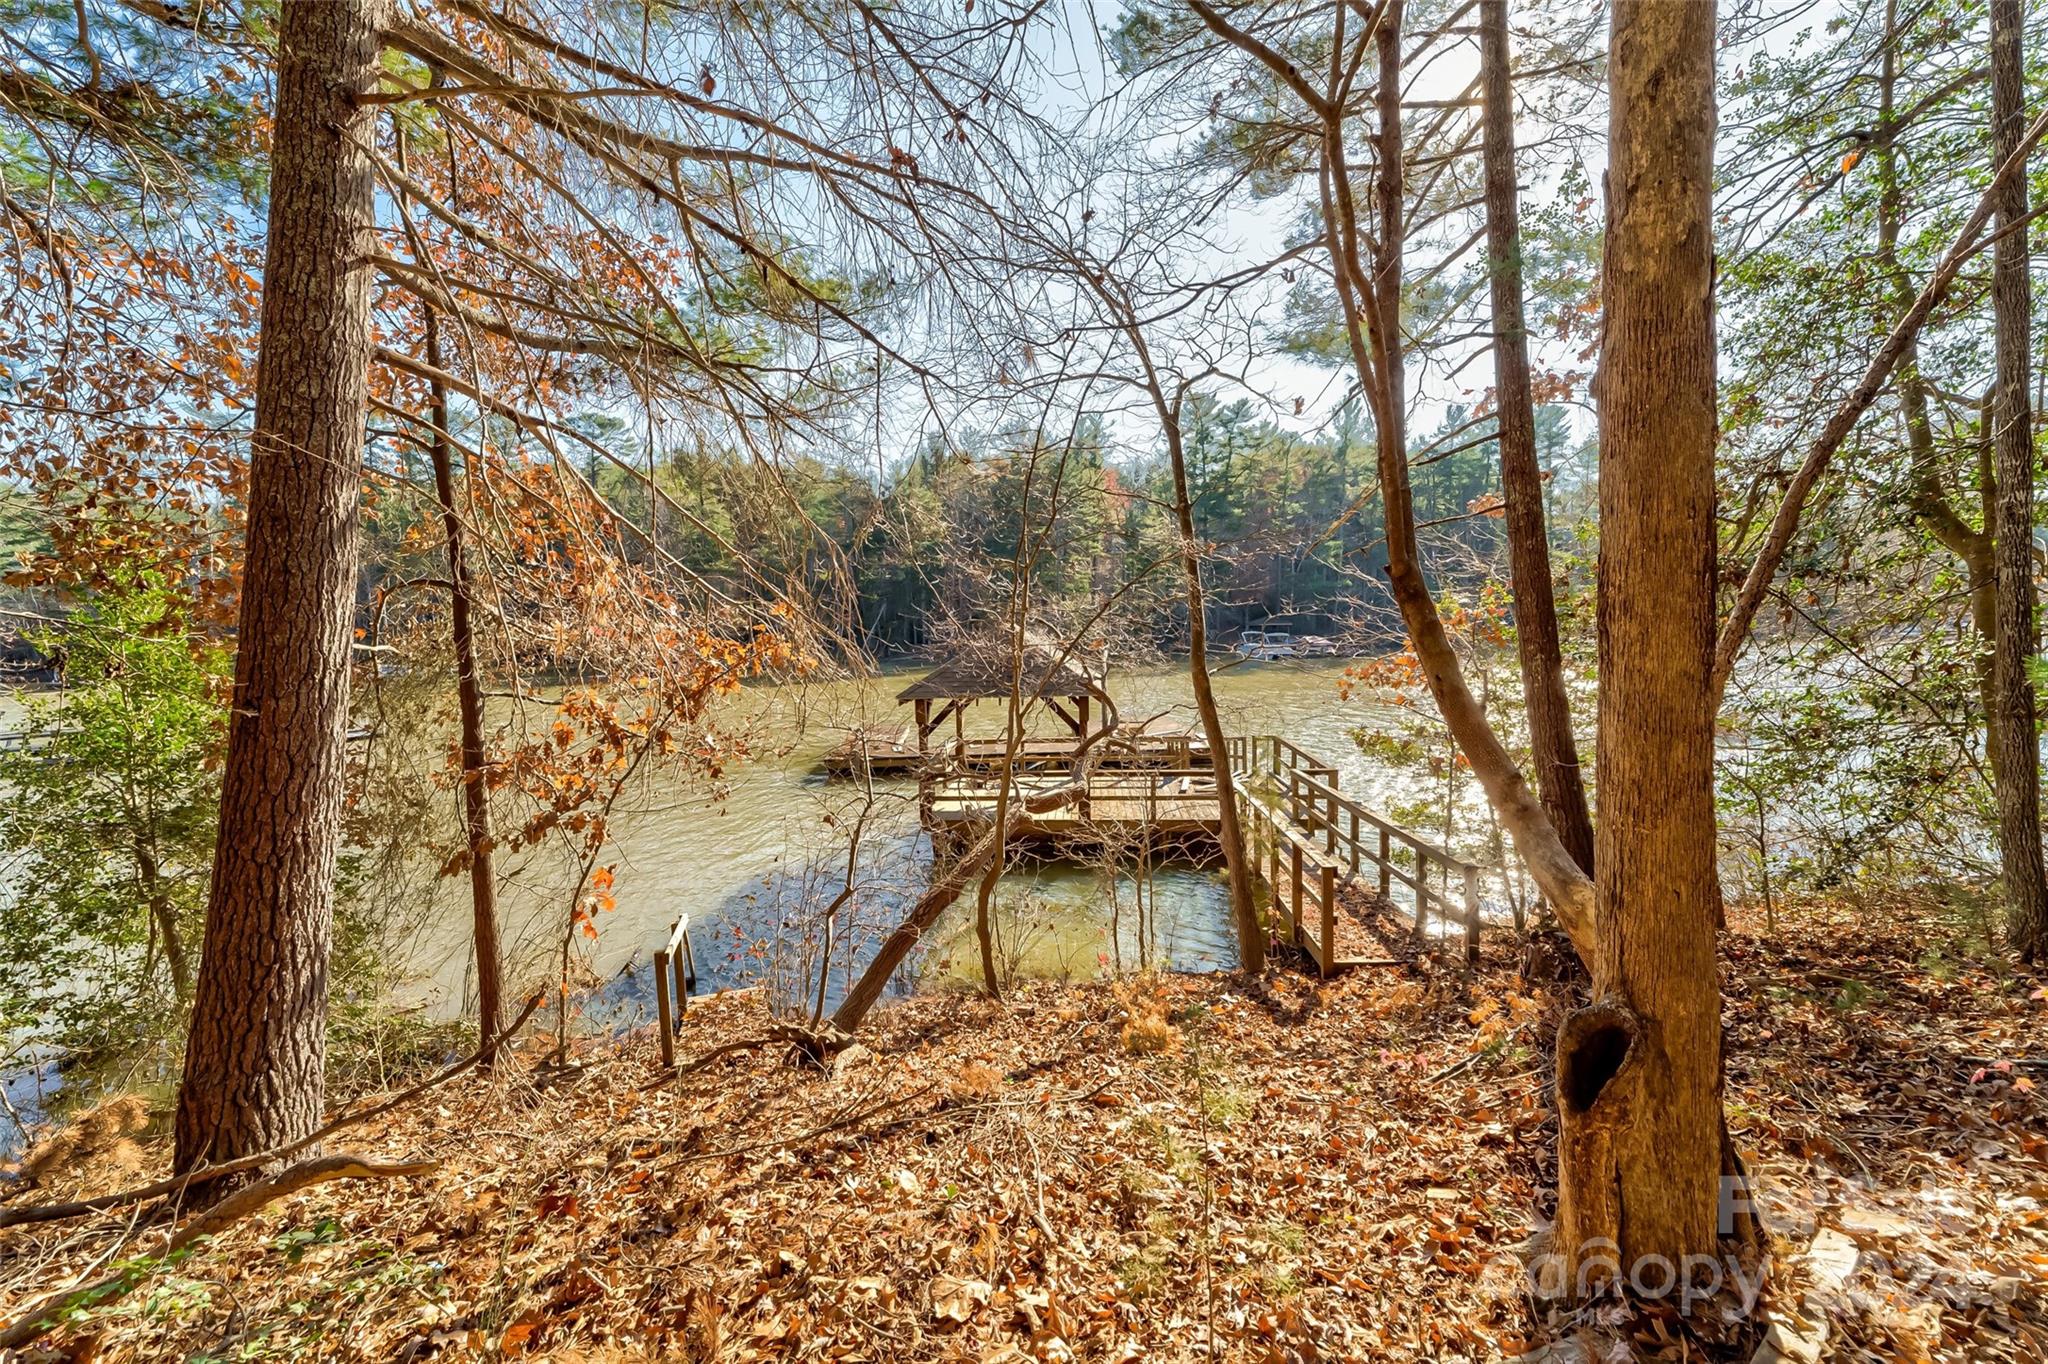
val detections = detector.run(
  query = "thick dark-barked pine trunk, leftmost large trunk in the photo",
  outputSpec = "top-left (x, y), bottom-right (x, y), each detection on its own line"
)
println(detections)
top-left (176, 0), bottom-right (381, 1169)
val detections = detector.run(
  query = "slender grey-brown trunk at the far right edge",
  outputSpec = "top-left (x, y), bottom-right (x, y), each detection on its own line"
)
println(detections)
top-left (1991, 0), bottom-right (2048, 961)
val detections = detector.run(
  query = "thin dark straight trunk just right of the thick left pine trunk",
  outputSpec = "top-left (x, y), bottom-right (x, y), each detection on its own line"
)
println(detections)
top-left (426, 307), bottom-right (504, 1069)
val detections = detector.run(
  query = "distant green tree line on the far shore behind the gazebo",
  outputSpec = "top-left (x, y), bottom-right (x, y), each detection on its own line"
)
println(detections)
top-left (557, 397), bottom-right (1593, 657)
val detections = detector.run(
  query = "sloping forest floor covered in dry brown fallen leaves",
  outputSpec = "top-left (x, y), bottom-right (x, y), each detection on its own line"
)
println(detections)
top-left (0, 907), bottom-right (2048, 1362)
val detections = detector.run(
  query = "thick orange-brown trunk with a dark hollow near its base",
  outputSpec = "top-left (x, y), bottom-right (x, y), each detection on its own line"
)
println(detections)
top-left (1556, 0), bottom-right (1724, 1294)
